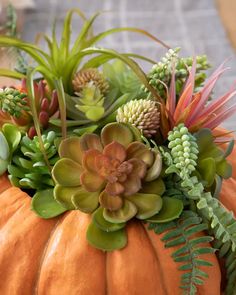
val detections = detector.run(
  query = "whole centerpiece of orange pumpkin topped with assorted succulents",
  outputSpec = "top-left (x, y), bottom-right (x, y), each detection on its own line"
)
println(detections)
top-left (0, 9), bottom-right (236, 295)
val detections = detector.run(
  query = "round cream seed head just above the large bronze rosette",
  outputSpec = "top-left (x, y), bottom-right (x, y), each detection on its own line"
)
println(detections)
top-left (116, 99), bottom-right (160, 137)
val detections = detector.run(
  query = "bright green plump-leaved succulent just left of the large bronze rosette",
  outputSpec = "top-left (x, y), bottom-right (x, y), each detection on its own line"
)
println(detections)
top-left (8, 131), bottom-right (58, 191)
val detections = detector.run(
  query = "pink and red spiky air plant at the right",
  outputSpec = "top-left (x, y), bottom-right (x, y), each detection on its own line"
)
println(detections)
top-left (165, 60), bottom-right (236, 132)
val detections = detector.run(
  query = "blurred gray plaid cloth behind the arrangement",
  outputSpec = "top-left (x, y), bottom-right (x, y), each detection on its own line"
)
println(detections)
top-left (19, 0), bottom-right (236, 129)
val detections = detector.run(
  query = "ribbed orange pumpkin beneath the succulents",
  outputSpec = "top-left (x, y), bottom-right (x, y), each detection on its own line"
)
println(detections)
top-left (0, 150), bottom-right (236, 295)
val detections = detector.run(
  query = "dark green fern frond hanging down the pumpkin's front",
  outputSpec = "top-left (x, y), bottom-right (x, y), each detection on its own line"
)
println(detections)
top-left (148, 211), bottom-right (215, 295)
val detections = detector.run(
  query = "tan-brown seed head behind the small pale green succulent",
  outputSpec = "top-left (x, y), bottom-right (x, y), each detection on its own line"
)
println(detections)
top-left (72, 68), bottom-right (109, 95)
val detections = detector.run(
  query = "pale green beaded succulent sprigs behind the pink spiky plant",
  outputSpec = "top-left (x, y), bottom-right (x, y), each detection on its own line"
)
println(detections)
top-left (146, 48), bottom-right (210, 98)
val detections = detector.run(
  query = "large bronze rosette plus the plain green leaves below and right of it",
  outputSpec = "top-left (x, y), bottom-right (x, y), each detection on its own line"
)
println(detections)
top-left (52, 123), bottom-right (183, 250)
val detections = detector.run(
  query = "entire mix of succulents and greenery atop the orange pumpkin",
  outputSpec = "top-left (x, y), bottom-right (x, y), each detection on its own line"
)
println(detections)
top-left (0, 6), bottom-right (236, 295)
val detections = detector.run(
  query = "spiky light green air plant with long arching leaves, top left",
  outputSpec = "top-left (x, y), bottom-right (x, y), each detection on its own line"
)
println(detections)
top-left (0, 9), bottom-right (168, 94)
